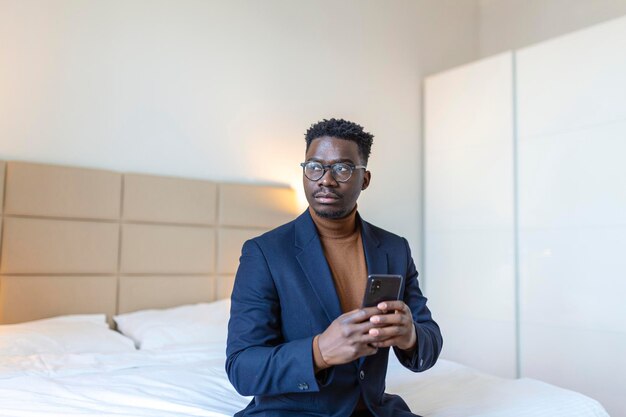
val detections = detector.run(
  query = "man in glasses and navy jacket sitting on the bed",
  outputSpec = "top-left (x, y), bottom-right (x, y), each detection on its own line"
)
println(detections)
top-left (226, 119), bottom-right (442, 417)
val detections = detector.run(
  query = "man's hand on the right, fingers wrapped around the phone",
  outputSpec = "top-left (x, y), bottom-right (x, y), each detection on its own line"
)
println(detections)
top-left (369, 301), bottom-right (417, 350)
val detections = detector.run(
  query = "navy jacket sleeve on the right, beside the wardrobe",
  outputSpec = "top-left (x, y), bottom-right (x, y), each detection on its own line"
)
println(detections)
top-left (394, 239), bottom-right (443, 372)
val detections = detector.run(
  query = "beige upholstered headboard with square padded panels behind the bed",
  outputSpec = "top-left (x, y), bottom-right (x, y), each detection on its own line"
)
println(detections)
top-left (0, 162), bottom-right (298, 323)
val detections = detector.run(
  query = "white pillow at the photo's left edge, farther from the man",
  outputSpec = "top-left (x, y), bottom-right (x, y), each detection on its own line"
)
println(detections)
top-left (0, 314), bottom-right (135, 356)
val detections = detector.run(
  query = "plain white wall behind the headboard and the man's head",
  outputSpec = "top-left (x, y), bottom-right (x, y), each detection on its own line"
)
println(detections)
top-left (0, 0), bottom-right (478, 256)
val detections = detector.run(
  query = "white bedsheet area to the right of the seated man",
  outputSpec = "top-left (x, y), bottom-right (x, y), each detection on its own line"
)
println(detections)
top-left (386, 354), bottom-right (609, 417)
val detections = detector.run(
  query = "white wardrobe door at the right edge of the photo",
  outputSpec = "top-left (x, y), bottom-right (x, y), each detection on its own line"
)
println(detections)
top-left (517, 18), bottom-right (626, 416)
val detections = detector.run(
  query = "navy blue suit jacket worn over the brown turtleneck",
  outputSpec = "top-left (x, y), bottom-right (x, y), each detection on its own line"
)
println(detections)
top-left (226, 210), bottom-right (442, 417)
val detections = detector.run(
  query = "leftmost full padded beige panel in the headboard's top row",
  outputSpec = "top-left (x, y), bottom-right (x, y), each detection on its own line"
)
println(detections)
top-left (5, 162), bottom-right (122, 219)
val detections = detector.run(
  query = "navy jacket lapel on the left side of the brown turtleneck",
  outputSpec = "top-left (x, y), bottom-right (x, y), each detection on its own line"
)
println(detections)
top-left (295, 210), bottom-right (341, 323)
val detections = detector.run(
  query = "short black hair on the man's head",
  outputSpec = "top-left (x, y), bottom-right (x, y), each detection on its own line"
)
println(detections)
top-left (304, 118), bottom-right (374, 165)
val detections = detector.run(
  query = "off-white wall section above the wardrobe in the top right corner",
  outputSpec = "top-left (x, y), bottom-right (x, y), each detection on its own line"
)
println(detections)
top-left (479, 0), bottom-right (626, 57)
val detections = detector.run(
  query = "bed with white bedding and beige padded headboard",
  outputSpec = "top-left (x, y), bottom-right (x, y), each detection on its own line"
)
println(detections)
top-left (0, 162), bottom-right (607, 417)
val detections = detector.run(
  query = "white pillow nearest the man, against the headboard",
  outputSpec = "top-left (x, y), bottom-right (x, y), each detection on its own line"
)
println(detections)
top-left (113, 299), bottom-right (230, 349)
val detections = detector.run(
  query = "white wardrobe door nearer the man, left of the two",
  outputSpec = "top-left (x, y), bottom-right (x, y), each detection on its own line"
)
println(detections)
top-left (423, 53), bottom-right (516, 377)
